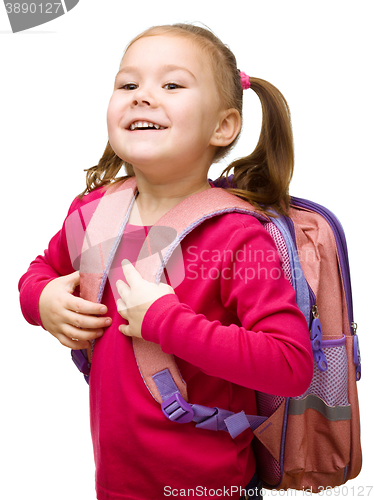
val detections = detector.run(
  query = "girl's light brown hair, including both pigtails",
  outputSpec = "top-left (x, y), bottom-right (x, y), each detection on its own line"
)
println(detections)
top-left (81, 24), bottom-right (294, 214)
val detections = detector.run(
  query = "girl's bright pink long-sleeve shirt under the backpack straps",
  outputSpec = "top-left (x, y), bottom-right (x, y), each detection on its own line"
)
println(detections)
top-left (19, 185), bottom-right (313, 500)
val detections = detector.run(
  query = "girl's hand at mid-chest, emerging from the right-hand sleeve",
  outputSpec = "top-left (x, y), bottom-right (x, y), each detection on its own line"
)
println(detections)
top-left (117, 260), bottom-right (174, 338)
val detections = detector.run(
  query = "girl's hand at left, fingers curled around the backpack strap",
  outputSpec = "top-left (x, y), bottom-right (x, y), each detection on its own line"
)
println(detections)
top-left (39, 271), bottom-right (112, 349)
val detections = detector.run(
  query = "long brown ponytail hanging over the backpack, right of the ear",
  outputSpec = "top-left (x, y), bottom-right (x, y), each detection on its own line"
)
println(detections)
top-left (219, 78), bottom-right (294, 215)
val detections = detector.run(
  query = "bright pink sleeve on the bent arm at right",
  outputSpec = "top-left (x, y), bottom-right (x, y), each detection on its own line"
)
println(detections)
top-left (142, 224), bottom-right (313, 397)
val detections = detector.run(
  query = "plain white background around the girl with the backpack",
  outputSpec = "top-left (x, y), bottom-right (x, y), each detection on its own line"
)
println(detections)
top-left (0, 0), bottom-right (374, 500)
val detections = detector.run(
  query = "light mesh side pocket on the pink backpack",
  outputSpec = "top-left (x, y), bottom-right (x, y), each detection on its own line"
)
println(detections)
top-left (293, 337), bottom-right (349, 406)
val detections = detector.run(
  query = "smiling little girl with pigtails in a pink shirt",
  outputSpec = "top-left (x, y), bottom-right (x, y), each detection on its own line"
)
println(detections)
top-left (19, 24), bottom-right (313, 500)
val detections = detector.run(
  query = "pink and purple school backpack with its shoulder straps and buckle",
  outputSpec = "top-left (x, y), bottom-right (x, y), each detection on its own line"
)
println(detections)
top-left (66, 178), bottom-right (362, 493)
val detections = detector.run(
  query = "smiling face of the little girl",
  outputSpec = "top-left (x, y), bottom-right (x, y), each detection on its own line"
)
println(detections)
top-left (107, 36), bottom-right (232, 183)
